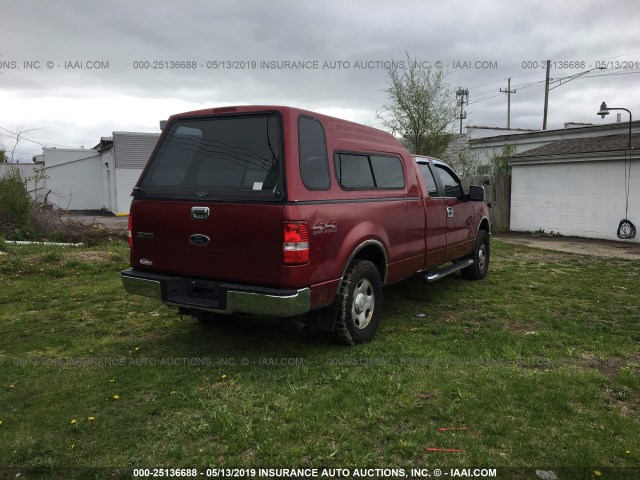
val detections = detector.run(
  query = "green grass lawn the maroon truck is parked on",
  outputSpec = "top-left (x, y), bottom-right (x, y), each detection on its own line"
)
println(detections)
top-left (0, 241), bottom-right (640, 478)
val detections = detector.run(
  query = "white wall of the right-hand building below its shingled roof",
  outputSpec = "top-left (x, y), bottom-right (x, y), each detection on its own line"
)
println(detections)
top-left (511, 160), bottom-right (640, 242)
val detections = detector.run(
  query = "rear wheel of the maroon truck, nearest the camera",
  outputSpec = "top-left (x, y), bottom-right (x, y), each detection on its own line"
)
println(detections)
top-left (333, 260), bottom-right (382, 345)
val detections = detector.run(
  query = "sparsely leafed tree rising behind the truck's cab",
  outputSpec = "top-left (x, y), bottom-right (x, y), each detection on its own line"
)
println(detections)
top-left (377, 53), bottom-right (456, 157)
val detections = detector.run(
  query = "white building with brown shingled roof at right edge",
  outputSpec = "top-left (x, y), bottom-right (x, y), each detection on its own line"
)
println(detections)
top-left (510, 134), bottom-right (640, 242)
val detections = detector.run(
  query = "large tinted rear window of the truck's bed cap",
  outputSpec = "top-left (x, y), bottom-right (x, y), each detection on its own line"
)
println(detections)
top-left (139, 114), bottom-right (282, 200)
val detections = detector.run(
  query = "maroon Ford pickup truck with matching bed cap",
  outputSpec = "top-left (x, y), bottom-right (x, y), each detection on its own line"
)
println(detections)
top-left (122, 106), bottom-right (490, 345)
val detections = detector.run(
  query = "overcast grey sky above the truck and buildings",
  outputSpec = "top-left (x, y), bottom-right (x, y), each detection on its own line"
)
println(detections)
top-left (0, 0), bottom-right (640, 160)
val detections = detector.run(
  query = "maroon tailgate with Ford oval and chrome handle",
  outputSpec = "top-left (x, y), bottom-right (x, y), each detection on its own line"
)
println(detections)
top-left (131, 199), bottom-right (283, 287)
